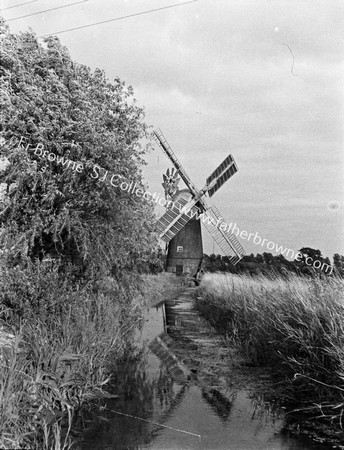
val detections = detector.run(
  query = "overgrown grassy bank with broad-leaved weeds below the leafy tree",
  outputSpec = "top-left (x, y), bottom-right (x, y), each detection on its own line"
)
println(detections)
top-left (0, 263), bottom-right (177, 450)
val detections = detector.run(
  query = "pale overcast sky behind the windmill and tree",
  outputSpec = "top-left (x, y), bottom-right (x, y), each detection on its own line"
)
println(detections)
top-left (0, 0), bottom-right (344, 256)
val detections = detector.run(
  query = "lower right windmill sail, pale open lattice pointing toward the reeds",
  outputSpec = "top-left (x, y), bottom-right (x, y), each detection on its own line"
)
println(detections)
top-left (203, 206), bottom-right (245, 264)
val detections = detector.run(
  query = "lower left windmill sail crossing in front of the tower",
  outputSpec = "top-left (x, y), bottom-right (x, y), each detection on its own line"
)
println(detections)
top-left (156, 197), bottom-right (198, 242)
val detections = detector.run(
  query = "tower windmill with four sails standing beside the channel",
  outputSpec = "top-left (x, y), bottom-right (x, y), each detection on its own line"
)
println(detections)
top-left (153, 130), bottom-right (245, 276)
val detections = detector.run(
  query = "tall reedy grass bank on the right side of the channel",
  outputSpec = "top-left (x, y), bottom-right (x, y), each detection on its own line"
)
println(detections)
top-left (197, 274), bottom-right (344, 439)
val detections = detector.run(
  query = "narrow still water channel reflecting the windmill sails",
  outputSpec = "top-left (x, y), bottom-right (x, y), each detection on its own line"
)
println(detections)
top-left (79, 296), bottom-right (327, 450)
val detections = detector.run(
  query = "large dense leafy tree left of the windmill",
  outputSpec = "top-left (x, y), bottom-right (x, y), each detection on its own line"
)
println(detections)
top-left (0, 22), bottom-right (155, 273)
